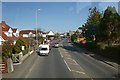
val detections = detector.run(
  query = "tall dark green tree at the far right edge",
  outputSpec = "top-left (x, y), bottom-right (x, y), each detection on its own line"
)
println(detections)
top-left (100, 6), bottom-right (120, 45)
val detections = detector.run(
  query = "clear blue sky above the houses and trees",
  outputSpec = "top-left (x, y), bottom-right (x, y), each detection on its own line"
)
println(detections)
top-left (2, 1), bottom-right (118, 33)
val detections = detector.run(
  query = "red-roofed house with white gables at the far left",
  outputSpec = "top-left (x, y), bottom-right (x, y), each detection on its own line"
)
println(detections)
top-left (0, 21), bottom-right (19, 45)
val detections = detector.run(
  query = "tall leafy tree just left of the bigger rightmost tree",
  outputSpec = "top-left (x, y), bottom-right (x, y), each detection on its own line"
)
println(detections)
top-left (83, 7), bottom-right (102, 39)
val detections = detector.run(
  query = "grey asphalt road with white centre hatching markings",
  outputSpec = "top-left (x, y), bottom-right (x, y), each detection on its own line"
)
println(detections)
top-left (3, 39), bottom-right (118, 80)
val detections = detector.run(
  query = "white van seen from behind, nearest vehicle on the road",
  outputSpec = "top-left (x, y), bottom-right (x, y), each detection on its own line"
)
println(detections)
top-left (38, 44), bottom-right (50, 55)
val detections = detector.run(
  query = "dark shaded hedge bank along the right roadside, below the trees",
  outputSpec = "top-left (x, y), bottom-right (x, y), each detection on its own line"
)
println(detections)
top-left (75, 41), bottom-right (120, 64)
